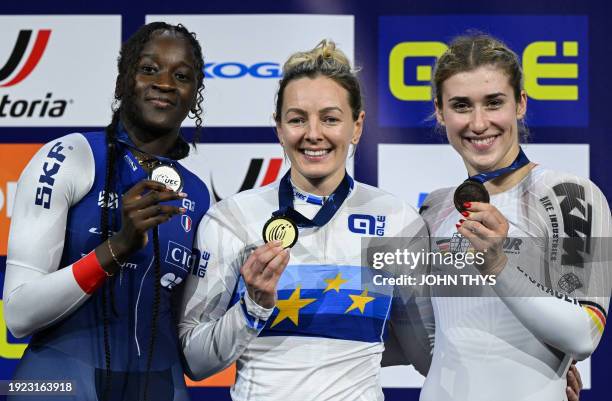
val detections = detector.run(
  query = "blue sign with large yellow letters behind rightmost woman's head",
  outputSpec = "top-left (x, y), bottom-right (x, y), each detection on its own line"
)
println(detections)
top-left (378, 15), bottom-right (589, 127)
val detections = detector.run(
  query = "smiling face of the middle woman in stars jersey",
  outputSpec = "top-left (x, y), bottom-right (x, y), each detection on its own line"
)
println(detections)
top-left (276, 75), bottom-right (365, 195)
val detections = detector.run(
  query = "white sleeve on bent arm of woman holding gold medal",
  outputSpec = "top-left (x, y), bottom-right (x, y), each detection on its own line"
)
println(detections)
top-left (179, 206), bottom-right (274, 380)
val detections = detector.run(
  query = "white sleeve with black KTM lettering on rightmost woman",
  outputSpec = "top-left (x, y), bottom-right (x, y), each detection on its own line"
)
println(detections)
top-left (494, 180), bottom-right (612, 360)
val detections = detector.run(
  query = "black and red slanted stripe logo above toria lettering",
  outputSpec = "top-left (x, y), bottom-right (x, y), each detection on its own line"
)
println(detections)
top-left (0, 29), bottom-right (51, 87)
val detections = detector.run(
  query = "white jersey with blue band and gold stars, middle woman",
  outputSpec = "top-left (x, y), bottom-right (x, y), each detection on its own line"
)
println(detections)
top-left (179, 179), bottom-right (429, 401)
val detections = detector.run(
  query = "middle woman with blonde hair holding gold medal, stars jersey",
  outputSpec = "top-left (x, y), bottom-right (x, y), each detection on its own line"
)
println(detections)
top-left (180, 41), bottom-right (429, 401)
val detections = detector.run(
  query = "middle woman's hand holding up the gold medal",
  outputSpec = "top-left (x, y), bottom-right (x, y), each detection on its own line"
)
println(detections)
top-left (240, 241), bottom-right (289, 309)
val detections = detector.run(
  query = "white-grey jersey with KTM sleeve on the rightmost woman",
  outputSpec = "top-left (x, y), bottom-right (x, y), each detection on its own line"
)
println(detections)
top-left (421, 166), bottom-right (612, 401)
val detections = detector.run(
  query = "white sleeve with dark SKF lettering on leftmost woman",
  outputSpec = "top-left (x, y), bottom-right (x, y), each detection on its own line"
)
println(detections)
top-left (4, 134), bottom-right (95, 337)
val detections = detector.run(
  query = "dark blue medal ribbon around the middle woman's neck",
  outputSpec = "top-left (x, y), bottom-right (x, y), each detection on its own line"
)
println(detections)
top-left (272, 170), bottom-right (355, 228)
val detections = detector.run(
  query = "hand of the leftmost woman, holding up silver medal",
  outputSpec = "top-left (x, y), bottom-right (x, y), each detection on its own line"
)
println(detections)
top-left (96, 180), bottom-right (187, 273)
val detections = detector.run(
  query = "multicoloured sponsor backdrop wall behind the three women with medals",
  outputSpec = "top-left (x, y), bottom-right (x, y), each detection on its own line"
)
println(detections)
top-left (0, 0), bottom-right (612, 401)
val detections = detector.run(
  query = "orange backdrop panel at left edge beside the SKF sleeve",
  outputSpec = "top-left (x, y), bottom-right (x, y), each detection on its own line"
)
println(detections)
top-left (0, 143), bottom-right (42, 255)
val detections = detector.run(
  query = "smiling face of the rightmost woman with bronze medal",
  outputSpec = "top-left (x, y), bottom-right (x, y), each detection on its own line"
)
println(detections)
top-left (435, 65), bottom-right (527, 175)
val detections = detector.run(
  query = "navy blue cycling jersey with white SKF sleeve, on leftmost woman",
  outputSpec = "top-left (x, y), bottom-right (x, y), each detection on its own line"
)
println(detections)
top-left (5, 132), bottom-right (210, 396)
